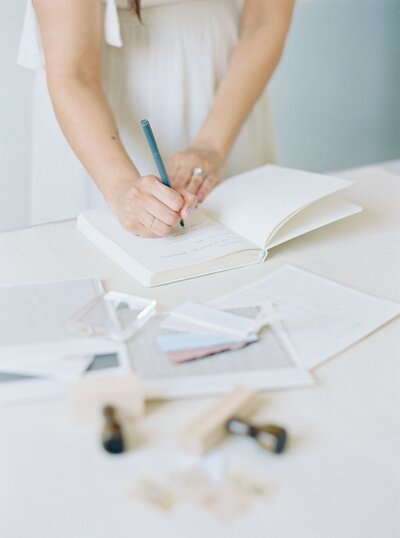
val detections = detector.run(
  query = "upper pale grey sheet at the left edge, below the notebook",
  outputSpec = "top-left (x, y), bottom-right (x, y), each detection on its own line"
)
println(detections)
top-left (0, 278), bottom-right (131, 360)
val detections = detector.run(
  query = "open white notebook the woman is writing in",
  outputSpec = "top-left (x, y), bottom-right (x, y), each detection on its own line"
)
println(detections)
top-left (77, 165), bottom-right (361, 286)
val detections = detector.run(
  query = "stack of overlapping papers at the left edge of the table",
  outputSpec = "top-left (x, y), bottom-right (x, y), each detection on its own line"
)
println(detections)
top-left (0, 279), bottom-right (128, 402)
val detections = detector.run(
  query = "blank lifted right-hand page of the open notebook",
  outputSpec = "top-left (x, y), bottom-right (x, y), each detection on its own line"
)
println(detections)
top-left (203, 165), bottom-right (353, 249)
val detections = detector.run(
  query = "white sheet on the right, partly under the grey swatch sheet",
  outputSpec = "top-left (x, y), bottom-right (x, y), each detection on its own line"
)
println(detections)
top-left (211, 265), bottom-right (400, 368)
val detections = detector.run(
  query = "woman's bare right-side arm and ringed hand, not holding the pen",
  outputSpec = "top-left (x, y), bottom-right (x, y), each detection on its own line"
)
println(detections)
top-left (169, 0), bottom-right (294, 201)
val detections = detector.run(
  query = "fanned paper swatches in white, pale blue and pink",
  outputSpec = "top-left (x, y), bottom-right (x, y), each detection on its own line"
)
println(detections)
top-left (157, 302), bottom-right (271, 363)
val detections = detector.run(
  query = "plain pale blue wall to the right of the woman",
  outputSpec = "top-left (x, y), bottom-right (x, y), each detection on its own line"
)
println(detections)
top-left (270, 0), bottom-right (400, 171)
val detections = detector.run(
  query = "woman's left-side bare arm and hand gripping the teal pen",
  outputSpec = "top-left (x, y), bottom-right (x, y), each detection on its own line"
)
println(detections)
top-left (35, 0), bottom-right (196, 236)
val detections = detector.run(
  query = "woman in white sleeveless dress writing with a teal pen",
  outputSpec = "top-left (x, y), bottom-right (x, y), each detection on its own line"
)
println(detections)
top-left (20, 0), bottom-right (294, 237)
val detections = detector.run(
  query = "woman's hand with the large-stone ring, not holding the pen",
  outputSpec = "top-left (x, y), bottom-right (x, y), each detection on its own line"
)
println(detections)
top-left (168, 144), bottom-right (223, 202)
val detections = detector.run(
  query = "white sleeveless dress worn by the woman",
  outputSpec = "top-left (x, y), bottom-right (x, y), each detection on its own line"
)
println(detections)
top-left (18, 0), bottom-right (275, 224)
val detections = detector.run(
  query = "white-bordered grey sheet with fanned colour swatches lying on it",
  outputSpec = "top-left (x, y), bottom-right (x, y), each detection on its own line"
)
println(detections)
top-left (128, 296), bottom-right (314, 399)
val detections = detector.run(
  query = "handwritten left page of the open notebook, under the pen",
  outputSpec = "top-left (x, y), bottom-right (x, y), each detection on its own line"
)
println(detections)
top-left (78, 205), bottom-right (255, 274)
